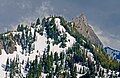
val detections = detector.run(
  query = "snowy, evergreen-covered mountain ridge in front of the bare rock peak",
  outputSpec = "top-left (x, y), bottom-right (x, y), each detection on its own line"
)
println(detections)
top-left (0, 16), bottom-right (120, 78)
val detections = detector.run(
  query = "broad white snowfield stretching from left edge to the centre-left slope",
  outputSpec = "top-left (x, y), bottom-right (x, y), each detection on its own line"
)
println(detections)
top-left (0, 32), bottom-right (47, 78)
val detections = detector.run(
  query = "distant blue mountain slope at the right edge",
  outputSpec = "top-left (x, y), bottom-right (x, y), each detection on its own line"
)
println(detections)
top-left (104, 47), bottom-right (120, 61)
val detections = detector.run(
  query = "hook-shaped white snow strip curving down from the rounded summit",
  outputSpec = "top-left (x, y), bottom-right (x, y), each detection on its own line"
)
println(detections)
top-left (50, 18), bottom-right (75, 55)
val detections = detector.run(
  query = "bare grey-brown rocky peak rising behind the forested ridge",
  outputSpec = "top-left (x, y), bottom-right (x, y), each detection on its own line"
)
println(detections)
top-left (73, 14), bottom-right (103, 47)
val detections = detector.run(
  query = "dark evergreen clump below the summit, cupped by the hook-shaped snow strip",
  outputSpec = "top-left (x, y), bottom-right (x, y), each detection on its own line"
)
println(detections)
top-left (43, 17), bottom-right (67, 48)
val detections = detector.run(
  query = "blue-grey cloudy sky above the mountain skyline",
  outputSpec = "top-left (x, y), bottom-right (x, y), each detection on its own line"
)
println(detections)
top-left (0, 0), bottom-right (120, 50)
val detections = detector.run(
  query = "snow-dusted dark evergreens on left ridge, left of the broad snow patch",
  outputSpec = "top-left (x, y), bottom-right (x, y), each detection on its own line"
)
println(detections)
top-left (14, 18), bottom-right (43, 54)
